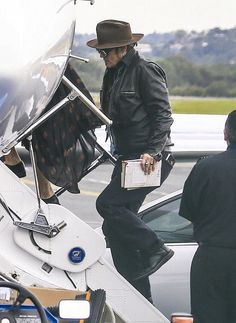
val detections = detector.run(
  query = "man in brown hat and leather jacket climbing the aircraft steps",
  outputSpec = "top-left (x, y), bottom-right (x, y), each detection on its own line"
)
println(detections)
top-left (87, 20), bottom-right (174, 301)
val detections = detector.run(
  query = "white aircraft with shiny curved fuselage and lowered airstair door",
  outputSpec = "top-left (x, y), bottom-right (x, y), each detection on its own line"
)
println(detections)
top-left (0, 0), bottom-right (168, 323)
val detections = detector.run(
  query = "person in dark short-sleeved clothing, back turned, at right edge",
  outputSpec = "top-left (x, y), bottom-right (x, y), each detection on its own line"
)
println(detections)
top-left (179, 110), bottom-right (236, 323)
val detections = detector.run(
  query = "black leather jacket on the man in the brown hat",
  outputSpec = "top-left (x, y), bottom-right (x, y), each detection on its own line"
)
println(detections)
top-left (101, 49), bottom-right (173, 155)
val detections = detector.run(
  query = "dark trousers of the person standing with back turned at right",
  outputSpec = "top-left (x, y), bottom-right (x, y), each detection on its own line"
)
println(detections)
top-left (191, 245), bottom-right (236, 323)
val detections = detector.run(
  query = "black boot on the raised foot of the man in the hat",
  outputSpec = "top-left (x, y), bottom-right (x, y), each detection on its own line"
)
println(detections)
top-left (133, 244), bottom-right (174, 280)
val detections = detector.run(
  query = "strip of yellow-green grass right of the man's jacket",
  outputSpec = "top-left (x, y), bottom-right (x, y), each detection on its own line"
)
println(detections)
top-left (170, 97), bottom-right (236, 115)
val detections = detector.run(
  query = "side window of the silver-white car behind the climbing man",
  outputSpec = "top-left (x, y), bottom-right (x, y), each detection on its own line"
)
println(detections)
top-left (142, 199), bottom-right (194, 243)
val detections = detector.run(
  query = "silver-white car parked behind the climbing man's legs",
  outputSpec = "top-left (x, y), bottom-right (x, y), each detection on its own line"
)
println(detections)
top-left (102, 190), bottom-right (197, 318)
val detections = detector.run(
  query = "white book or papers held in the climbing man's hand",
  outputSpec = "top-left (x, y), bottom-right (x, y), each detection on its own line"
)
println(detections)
top-left (121, 159), bottom-right (161, 189)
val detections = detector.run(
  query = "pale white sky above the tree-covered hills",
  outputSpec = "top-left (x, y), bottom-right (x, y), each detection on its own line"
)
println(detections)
top-left (76, 0), bottom-right (236, 34)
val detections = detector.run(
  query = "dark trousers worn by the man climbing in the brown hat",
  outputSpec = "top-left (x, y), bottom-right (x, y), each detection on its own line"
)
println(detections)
top-left (96, 161), bottom-right (162, 298)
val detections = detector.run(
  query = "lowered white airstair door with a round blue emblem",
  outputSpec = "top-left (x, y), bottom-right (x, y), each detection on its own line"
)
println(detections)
top-left (0, 162), bottom-right (169, 323)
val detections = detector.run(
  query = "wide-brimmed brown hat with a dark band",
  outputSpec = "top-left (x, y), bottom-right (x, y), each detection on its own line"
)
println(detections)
top-left (87, 19), bottom-right (144, 49)
